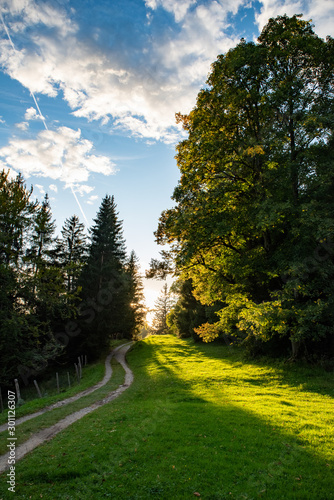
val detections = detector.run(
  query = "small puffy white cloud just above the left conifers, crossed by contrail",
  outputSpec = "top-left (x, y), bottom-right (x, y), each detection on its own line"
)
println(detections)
top-left (0, 127), bottom-right (115, 186)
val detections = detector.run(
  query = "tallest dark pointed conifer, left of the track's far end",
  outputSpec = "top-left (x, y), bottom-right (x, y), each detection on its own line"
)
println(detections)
top-left (79, 195), bottom-right (131, 355)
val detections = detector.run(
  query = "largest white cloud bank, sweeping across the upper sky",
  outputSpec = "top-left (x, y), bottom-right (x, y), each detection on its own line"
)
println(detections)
top-left (0, 0), bottom-right (245, 142)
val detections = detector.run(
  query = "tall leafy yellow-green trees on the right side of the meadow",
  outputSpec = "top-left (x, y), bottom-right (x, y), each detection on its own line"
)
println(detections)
top-left (148, 15), bottom-right (334, 356)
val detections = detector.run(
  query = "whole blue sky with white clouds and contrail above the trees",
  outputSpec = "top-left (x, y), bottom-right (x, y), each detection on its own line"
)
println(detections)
top-left (0, 0), bottom-right (334, 307)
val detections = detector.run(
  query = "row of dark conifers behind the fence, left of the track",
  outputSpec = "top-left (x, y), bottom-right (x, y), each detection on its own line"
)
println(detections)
top-left (0, 171), bottom-right (145, 384)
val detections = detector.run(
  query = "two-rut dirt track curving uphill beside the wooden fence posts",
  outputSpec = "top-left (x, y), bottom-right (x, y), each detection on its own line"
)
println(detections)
top-left (0, 343), bottom-right (133, 474)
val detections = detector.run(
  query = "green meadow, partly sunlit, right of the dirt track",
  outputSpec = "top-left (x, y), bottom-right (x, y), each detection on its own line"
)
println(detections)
top-left (0, 337), bottom-right (334, 500)
